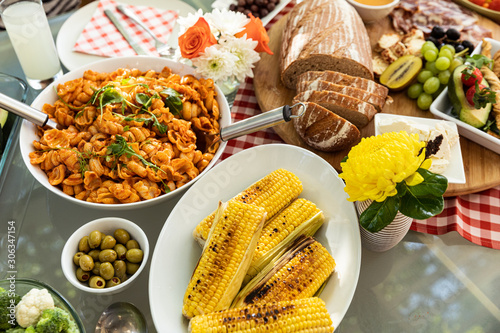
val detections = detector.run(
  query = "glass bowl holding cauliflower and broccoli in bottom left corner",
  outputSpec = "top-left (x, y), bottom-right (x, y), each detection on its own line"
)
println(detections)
top-left (0, 278), bottom-right (85, 333)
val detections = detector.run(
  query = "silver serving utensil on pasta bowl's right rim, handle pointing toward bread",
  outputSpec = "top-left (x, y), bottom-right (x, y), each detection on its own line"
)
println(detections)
top-left (194, 102), bottom-right (306, 152)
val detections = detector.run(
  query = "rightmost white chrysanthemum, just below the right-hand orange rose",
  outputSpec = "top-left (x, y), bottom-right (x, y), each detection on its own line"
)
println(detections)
top-left (221, 34), bottom-right (260, 82)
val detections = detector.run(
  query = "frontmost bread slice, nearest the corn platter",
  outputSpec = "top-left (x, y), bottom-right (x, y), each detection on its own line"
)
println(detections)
top-left (293, 102), bottom-right (361, 152)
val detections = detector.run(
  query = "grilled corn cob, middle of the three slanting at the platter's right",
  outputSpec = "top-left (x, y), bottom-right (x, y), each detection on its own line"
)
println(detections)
top-left (243, 198), bottom-right (324, 284)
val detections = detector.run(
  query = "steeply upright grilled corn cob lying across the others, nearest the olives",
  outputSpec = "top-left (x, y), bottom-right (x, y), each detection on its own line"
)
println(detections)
top-left (182, 201), bottom-right (266, 319)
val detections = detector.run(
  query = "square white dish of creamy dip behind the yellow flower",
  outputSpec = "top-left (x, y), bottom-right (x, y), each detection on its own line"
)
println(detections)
top-left (375, 113), bottom-right (466, 184)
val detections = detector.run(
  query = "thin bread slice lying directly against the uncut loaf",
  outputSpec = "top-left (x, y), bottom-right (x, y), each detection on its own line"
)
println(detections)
top-left (297, 71), bottom-right (389, 99)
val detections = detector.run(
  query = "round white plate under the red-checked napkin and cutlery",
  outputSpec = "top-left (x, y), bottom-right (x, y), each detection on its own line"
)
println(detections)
top-left (56, 0), bottom-right (195, 71)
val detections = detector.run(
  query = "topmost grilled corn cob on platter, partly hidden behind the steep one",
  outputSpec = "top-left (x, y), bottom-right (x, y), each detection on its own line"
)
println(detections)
top-left (193, 169), bottom-right (302, 246)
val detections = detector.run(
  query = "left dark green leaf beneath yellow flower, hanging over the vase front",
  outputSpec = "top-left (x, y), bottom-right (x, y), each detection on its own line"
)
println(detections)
top-left (359, 195), bottom-right (399, 232)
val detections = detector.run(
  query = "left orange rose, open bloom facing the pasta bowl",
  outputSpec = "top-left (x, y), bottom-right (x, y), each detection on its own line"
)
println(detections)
top-left (179, 17), bottom-right (217, 59)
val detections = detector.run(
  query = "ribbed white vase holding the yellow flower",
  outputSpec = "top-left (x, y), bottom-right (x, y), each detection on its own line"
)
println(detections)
top-left (356, 200), bottom-right (413, 252)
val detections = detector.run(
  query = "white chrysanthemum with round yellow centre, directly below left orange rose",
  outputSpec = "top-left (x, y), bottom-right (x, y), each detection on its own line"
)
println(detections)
top-left (192, 44), bottom-right (238, 81)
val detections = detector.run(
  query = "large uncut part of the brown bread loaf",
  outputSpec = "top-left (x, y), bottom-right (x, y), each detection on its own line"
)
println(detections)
top-left (280, 0), bottom-right (373, 89)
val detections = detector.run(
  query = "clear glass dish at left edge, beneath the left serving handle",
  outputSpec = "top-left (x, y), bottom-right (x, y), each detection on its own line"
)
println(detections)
top-left (0, 73), bottom-right (28, 184)
